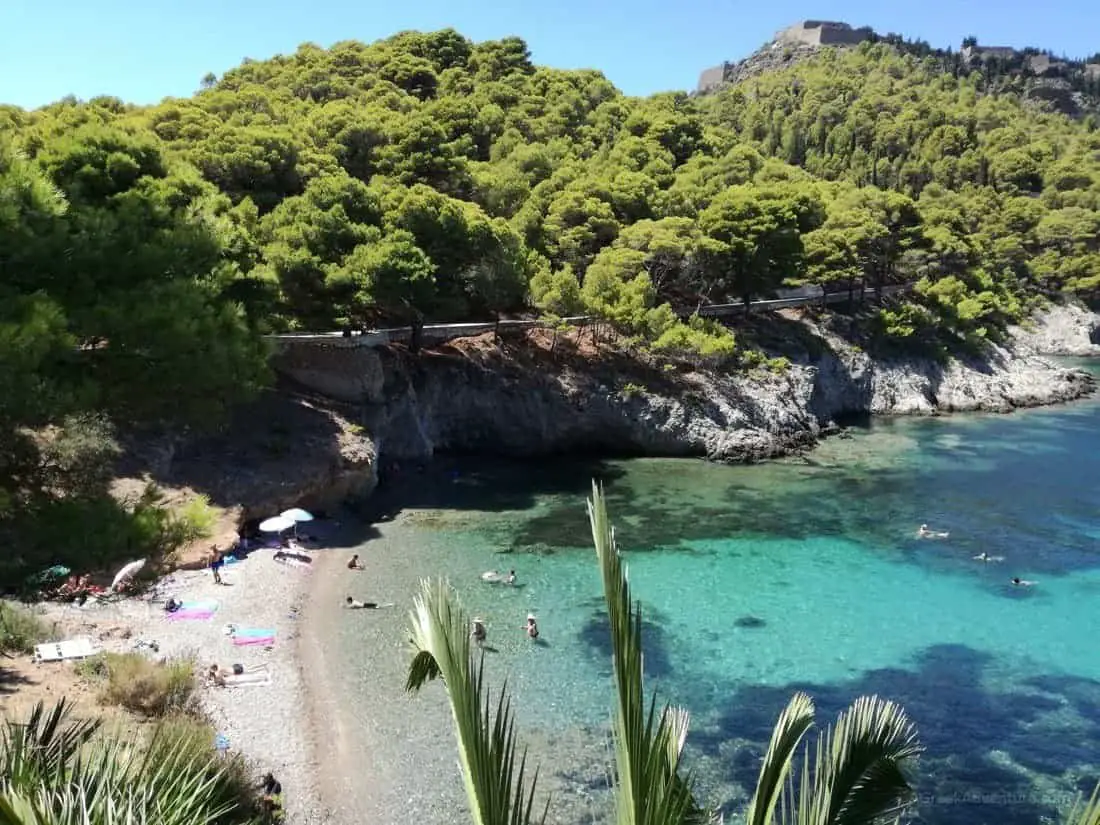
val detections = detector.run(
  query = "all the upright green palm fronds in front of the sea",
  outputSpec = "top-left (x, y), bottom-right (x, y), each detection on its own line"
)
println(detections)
top-left (407, 483), bottom-right (928, 825)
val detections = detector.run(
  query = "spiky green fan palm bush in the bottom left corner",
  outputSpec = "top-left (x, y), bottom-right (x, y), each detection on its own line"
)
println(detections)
top-left (0, 700), bottom-right (252, 825)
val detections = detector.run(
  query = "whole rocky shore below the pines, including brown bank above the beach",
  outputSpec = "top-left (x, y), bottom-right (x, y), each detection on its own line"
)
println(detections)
top-left (113, 305), bottom-right (1100, 524)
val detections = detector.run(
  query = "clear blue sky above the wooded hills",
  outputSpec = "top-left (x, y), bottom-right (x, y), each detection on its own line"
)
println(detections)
top-left (0, 0), bottom-right (1100, 108)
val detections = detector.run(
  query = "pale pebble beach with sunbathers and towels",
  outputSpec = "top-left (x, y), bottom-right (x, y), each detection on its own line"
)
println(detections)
top-left (39, 539), bottom-right (344, 824)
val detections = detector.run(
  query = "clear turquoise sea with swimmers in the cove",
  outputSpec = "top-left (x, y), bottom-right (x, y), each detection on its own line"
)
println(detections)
top-left (321, 367), bottom-right (1100, 825)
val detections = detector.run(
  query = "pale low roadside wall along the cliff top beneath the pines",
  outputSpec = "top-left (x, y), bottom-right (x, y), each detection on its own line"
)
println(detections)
top-left (267, 284), bottom-right (912, 348)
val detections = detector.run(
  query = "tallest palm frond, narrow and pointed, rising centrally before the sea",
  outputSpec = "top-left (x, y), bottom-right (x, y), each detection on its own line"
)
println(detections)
top-left (589, 482), bottom-right (711, 825)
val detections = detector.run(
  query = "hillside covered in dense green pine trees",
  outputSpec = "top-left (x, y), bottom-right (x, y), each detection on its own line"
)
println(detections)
top-left (0, 31), bottom-right (1100, 576)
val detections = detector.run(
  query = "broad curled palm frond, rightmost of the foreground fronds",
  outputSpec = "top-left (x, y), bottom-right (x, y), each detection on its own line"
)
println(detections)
top-left (796, 696), bottom-right (923, 825)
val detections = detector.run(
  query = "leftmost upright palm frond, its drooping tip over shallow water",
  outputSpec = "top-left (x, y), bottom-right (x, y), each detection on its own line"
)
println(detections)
top-left (405, 580), bottom-right (549, 825)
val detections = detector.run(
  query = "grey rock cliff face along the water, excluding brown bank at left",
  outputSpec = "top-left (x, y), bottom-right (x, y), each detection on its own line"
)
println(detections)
top-left (276, 311), bottom-right (1095, 461)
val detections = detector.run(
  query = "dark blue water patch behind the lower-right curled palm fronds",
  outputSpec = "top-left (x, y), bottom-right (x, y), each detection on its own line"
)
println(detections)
top-left (690, 645), bottom-right (1100, 825)
